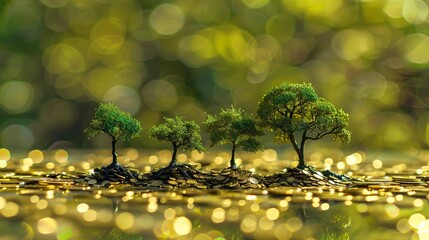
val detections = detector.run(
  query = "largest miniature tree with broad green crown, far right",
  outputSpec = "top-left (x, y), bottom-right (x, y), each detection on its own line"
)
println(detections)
top-left (257, 83), bottom-right (351, 168)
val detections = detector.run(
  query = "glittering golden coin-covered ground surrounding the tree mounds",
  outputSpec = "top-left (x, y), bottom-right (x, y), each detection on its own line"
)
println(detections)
top-left (0, 149), bottom-right (429, 240)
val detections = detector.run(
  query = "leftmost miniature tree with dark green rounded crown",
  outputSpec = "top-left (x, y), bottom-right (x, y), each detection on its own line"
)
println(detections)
top-left (84, 103), bottom-right (142, 168)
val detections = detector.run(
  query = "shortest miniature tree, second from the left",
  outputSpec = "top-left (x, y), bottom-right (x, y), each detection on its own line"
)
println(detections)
top-left (149, 117), bottom-right (204, 168)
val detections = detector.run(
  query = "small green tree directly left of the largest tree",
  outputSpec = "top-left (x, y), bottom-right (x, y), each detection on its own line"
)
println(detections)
top-left (204, 106), bottom-right (263, 169)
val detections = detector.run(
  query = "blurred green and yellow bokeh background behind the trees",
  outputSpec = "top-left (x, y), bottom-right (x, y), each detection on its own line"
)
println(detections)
top-left (0, 0), bottom-right (429, 150)
